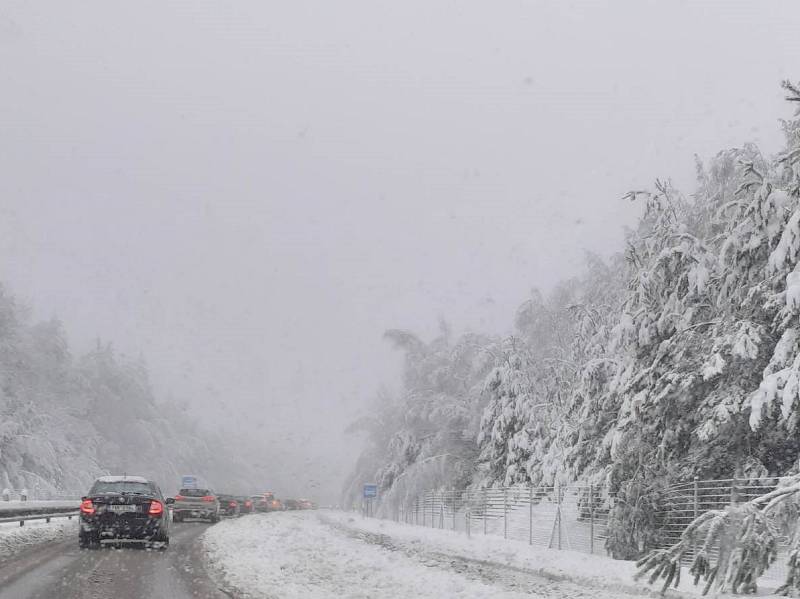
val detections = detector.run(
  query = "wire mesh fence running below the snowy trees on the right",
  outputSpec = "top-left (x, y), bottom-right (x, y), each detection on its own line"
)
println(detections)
top-left (360, 478), bottom-right (789, 583)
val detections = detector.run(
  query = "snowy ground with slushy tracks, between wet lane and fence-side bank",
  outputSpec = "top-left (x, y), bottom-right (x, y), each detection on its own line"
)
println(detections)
top-left (203, 512), bottom-right (664, 599)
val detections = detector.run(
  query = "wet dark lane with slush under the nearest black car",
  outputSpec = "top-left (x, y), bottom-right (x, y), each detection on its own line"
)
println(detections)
top-left (0, 522), bottom-right (231, 599)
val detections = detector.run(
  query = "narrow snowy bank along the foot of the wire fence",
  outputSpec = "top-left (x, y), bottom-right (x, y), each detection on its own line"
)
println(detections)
top-left (321, 512), bottom-right (776, 597)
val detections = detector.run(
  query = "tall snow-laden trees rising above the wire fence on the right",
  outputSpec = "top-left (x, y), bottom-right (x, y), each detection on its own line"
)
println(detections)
top-left (345, 82), bottom-right (800, 558)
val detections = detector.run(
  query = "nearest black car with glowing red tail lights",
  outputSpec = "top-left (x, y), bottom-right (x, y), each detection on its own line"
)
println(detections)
top-left (78, 476), bottom-right (172, 549)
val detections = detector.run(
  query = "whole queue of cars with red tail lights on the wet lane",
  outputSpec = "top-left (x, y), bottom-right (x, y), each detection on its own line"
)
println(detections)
top-left (78, 475), bottom-right (317, 549)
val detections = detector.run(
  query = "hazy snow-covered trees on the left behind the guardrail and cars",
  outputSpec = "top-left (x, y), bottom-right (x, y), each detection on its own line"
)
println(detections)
top-left (0, 287), bottom-right (252, 497)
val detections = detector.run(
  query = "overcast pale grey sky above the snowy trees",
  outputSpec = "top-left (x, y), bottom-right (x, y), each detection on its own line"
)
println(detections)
top-left (0, 0), bottom-right (800, 496)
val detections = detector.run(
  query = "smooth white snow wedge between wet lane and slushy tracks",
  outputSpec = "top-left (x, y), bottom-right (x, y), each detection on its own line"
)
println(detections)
top-left (204, 512), bottom-right (544, 599)
